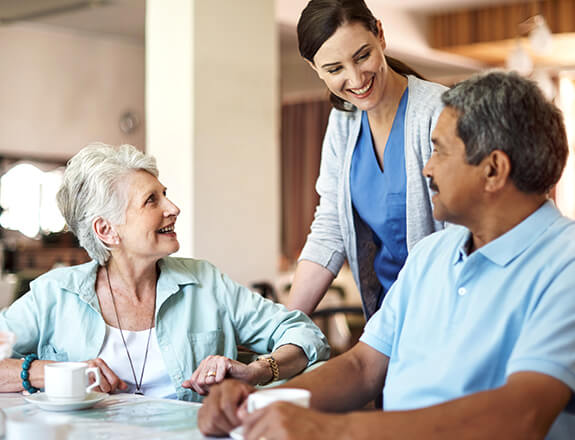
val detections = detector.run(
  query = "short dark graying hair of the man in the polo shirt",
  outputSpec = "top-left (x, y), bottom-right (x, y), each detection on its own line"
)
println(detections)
top-left (442, 71), bottom-right (569, 194)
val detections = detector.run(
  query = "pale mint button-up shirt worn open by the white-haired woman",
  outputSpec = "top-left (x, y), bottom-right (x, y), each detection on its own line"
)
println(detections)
top-left (0, 257), bottom-right (329, 401)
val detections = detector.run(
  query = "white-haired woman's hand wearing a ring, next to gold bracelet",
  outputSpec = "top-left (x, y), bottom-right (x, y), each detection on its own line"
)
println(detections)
top-left (182, 355), bottom-right (270, 396)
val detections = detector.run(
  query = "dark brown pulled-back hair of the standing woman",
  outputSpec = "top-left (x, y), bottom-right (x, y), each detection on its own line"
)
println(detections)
top-left (297, 0), bottom-right (421, 111)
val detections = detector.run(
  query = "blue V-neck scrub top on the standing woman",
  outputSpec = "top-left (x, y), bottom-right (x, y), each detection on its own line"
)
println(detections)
top-left (350, 89), bottom-right (408, 305)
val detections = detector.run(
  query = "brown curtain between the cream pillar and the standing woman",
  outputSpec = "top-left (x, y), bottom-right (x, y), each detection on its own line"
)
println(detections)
top-left (281, 100), bottom-right (331, 266)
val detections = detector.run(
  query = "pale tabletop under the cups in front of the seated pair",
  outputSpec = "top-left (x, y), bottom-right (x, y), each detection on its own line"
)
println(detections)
top-left (0, 393), bottom-right (230, 440)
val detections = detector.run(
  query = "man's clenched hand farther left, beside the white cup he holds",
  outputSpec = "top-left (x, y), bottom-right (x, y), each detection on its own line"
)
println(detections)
top-left (198, 379), bottom-right (255, 436)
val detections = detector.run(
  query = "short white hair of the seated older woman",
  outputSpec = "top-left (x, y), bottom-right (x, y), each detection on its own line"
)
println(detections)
top-left (56, 142), bottom-right (158, 265)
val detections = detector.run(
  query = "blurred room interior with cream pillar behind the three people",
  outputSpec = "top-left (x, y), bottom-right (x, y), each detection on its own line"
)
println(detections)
top-left (0, 0), bottom-right (575, 348)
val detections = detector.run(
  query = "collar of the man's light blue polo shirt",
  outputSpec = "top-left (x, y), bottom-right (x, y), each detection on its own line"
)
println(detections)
top-left (460, 200), bottom-right (561, 266)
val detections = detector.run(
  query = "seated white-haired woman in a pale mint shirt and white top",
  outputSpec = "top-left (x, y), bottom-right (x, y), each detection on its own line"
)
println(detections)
top-left (0, 144), bottom-right (329, 400)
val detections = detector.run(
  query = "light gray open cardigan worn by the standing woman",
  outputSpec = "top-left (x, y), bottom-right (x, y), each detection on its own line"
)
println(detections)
top-left (299, 76), bottom-right (445, 318)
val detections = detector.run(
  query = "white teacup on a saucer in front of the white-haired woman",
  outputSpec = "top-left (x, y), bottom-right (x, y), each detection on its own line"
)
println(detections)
top-left (44, 362), bottom-right (101, 402)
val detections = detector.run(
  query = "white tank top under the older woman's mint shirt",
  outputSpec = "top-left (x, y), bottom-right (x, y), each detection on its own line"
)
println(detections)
top-left (98, 325), bottom-right (176, 399)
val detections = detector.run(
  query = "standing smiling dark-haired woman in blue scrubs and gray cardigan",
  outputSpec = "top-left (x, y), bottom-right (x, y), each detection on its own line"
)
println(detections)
top-left (289, 0), bottom-right (445, 318)
